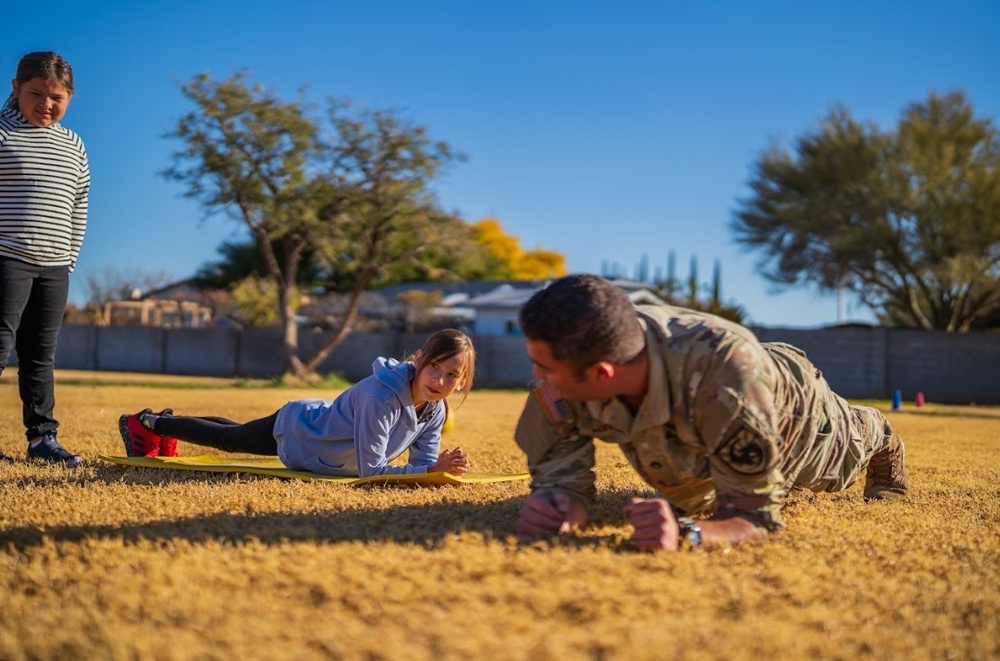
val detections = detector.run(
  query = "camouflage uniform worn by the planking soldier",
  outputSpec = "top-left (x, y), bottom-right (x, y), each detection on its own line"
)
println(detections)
top-left (515, 307), bottom-right (884, 530)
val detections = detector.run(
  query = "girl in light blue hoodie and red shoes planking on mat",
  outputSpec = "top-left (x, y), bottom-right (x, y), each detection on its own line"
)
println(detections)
top-left (118, 329), bottom-right (476, 477)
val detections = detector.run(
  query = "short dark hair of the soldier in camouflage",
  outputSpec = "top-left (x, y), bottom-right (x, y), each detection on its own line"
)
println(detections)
top-left (520, 274), bottom-right (645, 377)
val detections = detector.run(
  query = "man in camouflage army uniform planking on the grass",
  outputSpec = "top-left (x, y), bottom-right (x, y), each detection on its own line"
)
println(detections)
top-left (515, 275), bottom-right (908, 550)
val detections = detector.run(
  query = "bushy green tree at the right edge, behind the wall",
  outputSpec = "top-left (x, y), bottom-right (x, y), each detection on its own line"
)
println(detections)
top-left (731, 92), bottom-right (1000, 331)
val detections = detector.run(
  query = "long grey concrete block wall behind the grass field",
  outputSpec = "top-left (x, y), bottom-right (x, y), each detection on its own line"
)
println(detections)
top-left (43, 326), bottom-right (1000, 404)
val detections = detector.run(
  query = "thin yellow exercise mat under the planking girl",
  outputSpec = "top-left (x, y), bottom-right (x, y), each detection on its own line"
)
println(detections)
top-left (98, 454), bottom-right (530, 485)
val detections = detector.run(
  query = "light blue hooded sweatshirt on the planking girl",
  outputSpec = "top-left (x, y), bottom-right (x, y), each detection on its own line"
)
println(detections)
top-left (274, 358), bottom-right (445, 477)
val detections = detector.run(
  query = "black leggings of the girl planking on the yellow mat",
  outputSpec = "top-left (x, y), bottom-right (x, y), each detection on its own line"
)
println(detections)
top-left (153, 411), bottom-right (278, 456)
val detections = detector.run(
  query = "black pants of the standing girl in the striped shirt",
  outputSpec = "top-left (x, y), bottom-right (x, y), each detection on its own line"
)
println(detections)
top-left (0, 257), bottom-right (69, 440)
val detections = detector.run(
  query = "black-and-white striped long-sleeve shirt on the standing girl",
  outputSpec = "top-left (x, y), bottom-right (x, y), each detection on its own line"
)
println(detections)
top-left (0, 108), bottom-right (90, 271)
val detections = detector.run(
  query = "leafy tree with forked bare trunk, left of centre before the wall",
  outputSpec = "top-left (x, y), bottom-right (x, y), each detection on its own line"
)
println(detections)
top-left (164, 73), bottom-right (464, 377)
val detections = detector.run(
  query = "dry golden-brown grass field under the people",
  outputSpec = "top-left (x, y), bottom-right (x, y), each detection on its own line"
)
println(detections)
top-left (0, 370), bottom-right (1000, 660)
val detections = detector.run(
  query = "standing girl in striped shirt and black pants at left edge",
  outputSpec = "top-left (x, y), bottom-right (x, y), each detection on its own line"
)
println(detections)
top-left (0, 51), bottom-right (90, 466)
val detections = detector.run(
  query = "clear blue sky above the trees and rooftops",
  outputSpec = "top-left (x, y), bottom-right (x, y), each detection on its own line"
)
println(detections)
top-left (0, 0), bottom-right (1000, 327)
